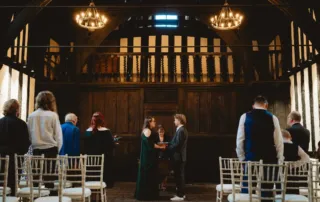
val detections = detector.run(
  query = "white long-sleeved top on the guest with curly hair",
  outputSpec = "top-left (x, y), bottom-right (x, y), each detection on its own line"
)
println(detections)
top-left (28, 109), bottom-right (63, 152)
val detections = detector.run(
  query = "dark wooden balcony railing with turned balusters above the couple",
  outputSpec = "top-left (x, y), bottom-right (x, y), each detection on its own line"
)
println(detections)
top-left (81, 53), bottom-right (243, 82)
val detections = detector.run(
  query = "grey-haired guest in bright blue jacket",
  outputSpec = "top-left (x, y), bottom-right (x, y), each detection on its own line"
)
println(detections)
top-left (60, 113), bottom-right (80, 156)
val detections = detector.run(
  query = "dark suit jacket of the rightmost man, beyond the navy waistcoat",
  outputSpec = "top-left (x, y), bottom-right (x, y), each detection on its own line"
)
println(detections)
top-left (287, 123), bottom-right (310, 153)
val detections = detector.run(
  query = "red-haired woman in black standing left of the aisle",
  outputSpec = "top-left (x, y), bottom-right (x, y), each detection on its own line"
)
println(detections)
top-left (85, 112), bottom-right (114, 188)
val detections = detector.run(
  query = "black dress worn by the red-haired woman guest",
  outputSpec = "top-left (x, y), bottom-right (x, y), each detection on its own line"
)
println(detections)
top-left (85, 128), bottom-right (114, 188)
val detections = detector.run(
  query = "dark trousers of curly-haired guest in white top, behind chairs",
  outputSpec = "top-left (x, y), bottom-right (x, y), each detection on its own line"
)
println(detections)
top-left (33, 147), bottom-right (58, 188)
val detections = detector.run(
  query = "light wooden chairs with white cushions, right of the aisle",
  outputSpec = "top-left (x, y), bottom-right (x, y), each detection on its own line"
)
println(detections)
top-left (216, 157), bottom-right (320, 202)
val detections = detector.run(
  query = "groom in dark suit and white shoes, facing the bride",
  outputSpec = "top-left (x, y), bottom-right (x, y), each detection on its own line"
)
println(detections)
top-left (168, 114), bottom-right (188, 201)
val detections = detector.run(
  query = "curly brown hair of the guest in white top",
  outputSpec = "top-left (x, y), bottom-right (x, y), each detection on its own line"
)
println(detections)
top-left (36, 91), bottom-right (57, 112)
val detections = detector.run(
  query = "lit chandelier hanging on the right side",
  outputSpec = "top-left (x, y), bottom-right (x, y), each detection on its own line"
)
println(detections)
top-left (211, 0), bottom-right (243, 30)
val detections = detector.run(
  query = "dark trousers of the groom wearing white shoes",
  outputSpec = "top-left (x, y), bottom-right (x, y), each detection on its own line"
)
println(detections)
top-left (173, 161), bottom-right (186, 197)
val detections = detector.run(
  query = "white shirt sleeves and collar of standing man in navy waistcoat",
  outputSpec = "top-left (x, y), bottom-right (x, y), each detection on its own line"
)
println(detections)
top-left (236, 107), bottom-right (284, 161)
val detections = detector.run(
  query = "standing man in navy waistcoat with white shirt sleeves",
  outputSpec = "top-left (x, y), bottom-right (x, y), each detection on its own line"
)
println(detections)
top-left (236, 96), bottom-right (283, 200)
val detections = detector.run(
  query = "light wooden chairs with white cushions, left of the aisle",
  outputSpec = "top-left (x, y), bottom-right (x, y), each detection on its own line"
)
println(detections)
top-left (0, 155), bottom-right (107, 202)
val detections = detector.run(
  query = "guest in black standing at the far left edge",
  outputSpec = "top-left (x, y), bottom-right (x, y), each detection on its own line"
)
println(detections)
top-left (0, 99), bottom-right (30, 195)
